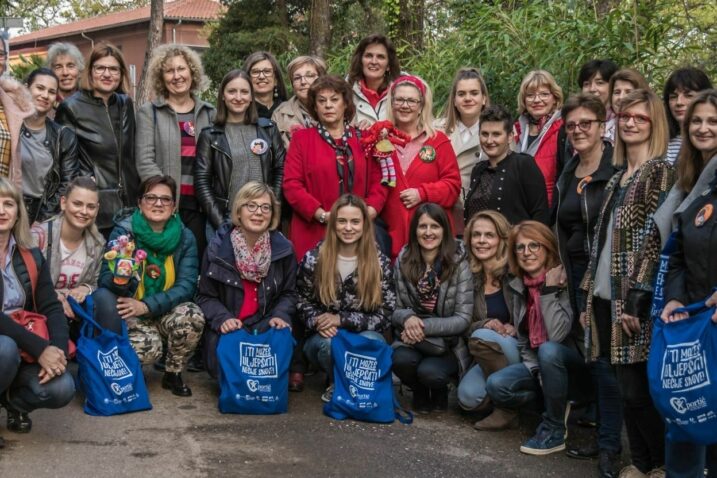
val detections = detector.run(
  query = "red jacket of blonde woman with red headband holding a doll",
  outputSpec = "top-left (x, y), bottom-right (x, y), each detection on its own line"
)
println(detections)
top-left (381, 131), bottom-right (461, 260)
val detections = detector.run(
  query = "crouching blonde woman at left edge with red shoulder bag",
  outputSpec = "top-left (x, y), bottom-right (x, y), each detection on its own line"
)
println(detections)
top-left (0, 178), bottom-right (75, 444)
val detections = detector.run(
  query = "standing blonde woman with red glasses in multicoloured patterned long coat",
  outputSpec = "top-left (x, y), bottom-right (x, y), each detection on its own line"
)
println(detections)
top-left (580, 89), bottom-right (675, 476)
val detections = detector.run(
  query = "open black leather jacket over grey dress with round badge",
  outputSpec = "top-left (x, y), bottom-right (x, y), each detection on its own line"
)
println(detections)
top-left (194, 118), bottom-right (286, 228)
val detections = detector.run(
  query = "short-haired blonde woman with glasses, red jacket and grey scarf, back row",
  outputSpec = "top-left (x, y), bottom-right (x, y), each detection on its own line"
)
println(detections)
top-left (514, 70), bottom-right (567, 206)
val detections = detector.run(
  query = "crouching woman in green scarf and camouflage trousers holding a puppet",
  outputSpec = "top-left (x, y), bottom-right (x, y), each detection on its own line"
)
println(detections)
top-left (94, 176), bottom-right (204, 397)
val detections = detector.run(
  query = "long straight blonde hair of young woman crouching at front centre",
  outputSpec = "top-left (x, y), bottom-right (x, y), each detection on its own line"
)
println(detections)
top-left (314, 194), bottom-right (384, 311)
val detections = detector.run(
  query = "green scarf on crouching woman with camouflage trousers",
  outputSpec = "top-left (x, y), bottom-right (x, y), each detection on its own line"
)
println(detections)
top-left (132, 209), bottom-right (182, 297)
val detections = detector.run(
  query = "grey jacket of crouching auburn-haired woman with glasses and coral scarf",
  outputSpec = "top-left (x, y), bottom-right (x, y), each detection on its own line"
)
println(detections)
top-left (507, 277), bottom-right (584, 372)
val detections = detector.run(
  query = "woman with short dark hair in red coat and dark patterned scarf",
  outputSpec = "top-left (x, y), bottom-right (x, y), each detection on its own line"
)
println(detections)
top-left (284, 76), bottom-right (388, 257)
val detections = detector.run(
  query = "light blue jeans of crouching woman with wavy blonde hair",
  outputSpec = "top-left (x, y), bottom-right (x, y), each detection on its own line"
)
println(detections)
top-left (458, 329), bottom-right (520, 410)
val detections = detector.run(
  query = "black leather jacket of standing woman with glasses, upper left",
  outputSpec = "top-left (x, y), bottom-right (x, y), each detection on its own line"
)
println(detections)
top-left (55, 90), bottom-right (140, 229)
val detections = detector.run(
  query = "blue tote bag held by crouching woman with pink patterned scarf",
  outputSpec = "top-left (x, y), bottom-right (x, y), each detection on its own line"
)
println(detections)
top-left (217, 327), bottom-right (294, 415)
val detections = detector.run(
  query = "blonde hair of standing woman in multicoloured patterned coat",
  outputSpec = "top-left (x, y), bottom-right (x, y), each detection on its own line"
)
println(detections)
top-left (612, 89), bottom-right (670, 167)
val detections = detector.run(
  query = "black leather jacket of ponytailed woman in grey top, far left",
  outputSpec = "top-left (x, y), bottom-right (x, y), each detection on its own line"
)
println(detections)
top-left (21, 118), bottom-right (83, 224)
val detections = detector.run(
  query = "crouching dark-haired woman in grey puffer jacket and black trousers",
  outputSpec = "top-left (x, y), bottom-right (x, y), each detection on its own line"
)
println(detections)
top-left (392, 203), bottom-right (473, 413)
